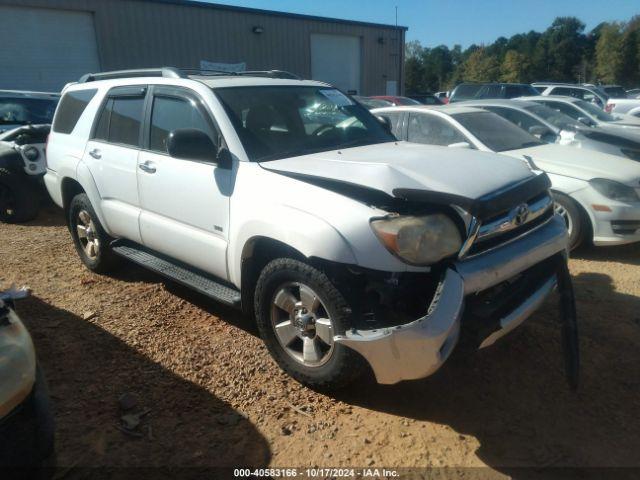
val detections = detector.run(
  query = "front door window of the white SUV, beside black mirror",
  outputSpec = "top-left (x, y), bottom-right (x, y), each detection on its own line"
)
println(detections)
top-left (149, 96), bottom-right (211, 153)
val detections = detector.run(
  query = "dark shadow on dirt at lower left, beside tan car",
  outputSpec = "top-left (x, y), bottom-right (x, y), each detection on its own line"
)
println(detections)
top-left (17, 297), bottom-right (271, 472)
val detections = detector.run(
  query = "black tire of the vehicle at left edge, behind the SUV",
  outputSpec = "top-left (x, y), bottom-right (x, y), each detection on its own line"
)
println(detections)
top-left (0, 168), bottom-right (40, 223)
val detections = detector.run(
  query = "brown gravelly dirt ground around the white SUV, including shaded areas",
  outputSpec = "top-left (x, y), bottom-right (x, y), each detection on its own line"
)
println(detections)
top-left (0, 207), bottom-right (640, 476)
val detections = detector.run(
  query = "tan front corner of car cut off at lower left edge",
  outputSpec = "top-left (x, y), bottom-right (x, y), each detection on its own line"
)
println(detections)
top-left (0, 300), bottom-right (36, 418)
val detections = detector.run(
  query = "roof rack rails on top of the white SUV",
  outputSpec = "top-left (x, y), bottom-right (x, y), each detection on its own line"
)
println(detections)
top-left (78, 67), bottom-right (301, 83)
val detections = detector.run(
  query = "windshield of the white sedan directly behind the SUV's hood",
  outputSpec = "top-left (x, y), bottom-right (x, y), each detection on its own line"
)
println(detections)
top-left (451, 112), bottom-right (543, 152)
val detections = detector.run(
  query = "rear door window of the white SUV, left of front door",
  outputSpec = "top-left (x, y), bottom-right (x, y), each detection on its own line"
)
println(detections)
top-left (94, 97), bottom-right (144, 147)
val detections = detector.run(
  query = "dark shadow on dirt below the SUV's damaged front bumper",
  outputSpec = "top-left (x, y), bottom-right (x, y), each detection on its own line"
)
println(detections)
top-left (339, 273), bottom-right (640, 472)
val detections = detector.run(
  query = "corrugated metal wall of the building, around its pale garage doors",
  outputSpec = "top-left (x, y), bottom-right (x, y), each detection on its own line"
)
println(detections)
top-left (0, 0), bottom-right (404, 95)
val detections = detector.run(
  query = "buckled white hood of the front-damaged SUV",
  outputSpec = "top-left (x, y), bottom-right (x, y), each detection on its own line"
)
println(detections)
top-left (261, 142), bottom-right (534, 199)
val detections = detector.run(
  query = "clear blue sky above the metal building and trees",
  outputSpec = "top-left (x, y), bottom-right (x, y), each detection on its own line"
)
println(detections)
top-left (208, 0), bottom-right (640, 48)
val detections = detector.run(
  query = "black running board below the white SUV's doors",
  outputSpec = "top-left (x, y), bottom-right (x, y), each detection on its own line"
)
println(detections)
top-left (111, 240), bottom-right (240, 307)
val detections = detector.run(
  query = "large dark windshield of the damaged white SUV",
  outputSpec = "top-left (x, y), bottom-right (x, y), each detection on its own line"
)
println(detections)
top-left (214, 86), bottom-right (395, 162)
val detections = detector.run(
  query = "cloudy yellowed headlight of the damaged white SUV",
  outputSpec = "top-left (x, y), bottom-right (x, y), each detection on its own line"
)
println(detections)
top-left (371, 213), bottom-right (462, 265)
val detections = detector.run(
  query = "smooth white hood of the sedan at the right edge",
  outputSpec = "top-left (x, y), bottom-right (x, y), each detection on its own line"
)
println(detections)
top-left (503, 144), bottom-right (640, 186)
